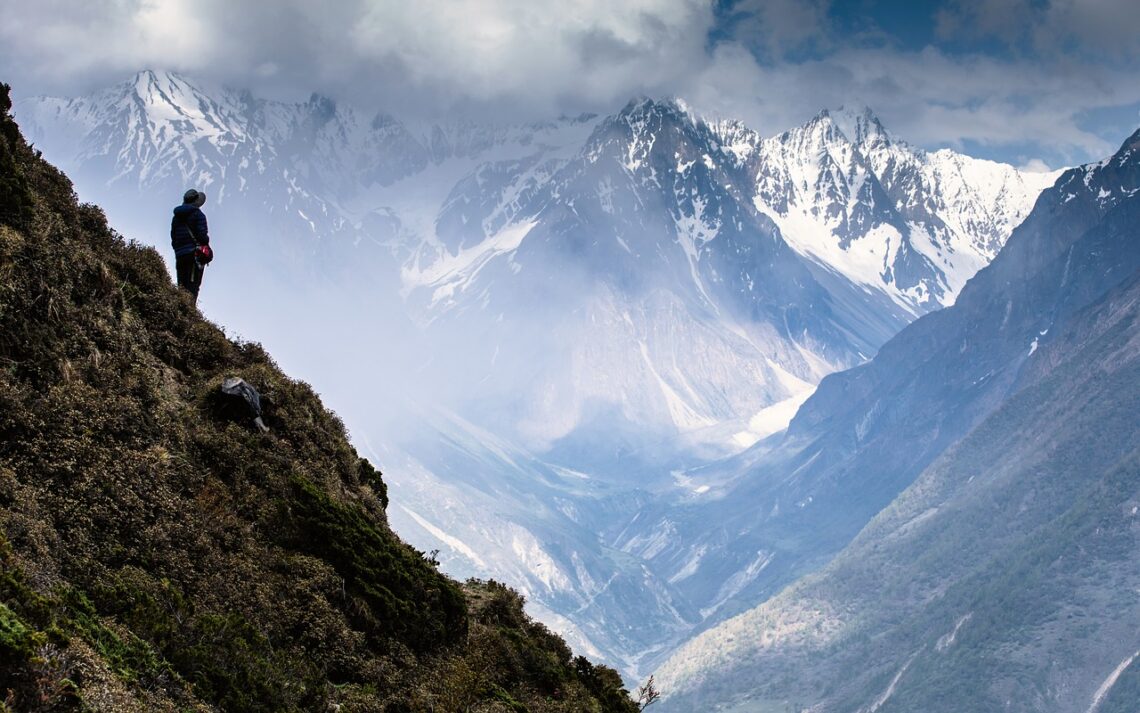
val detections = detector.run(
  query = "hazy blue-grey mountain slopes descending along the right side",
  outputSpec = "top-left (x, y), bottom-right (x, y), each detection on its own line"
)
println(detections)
top-left (660, 132), bottom-right (1140, 712)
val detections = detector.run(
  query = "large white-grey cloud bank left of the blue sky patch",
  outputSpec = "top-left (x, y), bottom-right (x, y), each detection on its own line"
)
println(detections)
top-left (0, 0), bottom-right (714, 117)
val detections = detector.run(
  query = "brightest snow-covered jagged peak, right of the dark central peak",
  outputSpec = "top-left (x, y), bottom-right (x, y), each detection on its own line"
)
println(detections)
top-left (752, 104), bottom-right (1057, 315)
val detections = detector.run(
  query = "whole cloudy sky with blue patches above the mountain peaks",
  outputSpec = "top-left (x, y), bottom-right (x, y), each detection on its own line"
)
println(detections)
top-left (0, 0), bottom-right (1140, 168)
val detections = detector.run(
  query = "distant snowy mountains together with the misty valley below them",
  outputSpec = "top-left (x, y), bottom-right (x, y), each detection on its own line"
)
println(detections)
top-left (16, 72), bottom-right (1052, 671)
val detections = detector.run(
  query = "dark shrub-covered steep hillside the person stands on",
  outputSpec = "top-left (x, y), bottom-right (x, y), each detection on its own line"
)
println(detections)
top-left (0, 86), bottom-right (637, 712)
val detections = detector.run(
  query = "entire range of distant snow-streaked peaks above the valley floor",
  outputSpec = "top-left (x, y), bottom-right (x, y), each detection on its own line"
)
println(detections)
top-left (16, 72), bottom-right (1055, 447)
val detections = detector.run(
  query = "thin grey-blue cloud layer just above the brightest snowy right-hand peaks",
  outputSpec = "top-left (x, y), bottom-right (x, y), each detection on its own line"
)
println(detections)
top-left (687, 44), bottom-right (1140, 165)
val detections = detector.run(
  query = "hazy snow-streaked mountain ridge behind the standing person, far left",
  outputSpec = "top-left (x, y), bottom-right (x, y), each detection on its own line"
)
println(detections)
top-left (17, 71), bottom-right (588, 273)
